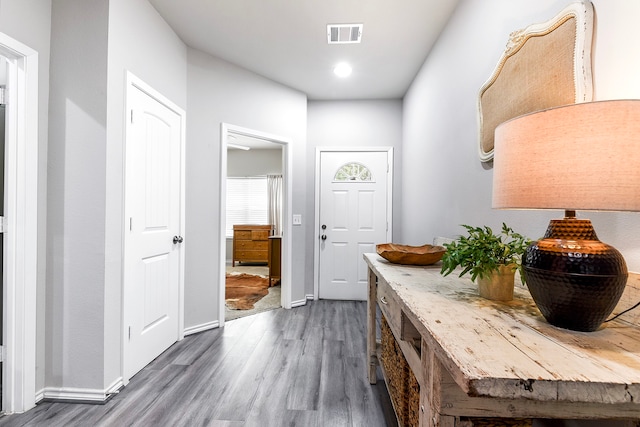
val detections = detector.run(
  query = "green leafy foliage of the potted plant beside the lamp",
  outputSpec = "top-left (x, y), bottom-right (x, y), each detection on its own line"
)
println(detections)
top-left (440, 223), bottom-right (531, 282)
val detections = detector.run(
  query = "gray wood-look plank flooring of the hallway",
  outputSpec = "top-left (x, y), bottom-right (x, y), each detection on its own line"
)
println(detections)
top-left (0, 300), bottom-right (396, 427)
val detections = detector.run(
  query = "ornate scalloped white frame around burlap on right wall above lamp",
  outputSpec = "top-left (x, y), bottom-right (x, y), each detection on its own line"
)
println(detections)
top-left (478, 0), bottom-right (593, 162)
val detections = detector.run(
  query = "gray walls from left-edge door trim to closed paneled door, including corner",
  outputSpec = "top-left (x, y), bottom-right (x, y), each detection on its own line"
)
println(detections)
top-left (45, 0), bottom-right (186, 390)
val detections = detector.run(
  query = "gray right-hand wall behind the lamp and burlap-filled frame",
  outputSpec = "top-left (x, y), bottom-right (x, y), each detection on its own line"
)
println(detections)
top-left (398, 0), bottom-right (640, 272)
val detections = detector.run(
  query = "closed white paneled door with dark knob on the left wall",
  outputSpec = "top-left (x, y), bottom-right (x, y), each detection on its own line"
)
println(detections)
top-left (124, 78), bottom-right (184, 381)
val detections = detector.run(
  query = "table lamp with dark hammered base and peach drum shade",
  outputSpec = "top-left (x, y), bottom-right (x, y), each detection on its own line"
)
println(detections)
top-left (493, 100), bottom-right (640, 331)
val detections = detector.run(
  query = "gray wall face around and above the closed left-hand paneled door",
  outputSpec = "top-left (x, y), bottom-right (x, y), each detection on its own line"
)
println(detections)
top-left (104, 0), bottom-right (189, 387)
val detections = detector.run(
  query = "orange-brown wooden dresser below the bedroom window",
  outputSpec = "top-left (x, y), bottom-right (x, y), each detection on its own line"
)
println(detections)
top-left (232, 224), bottom-right (273, 267)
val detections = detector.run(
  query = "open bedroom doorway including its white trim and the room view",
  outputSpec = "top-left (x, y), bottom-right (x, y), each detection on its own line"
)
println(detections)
top-left (219, 124), bottom-right (291, 325)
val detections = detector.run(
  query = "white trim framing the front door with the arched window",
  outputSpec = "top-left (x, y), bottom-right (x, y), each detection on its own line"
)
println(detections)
top-left (313, 147), bottom-right (393, 300)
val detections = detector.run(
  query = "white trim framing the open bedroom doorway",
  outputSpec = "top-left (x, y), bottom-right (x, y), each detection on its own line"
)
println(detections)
top-left (218, 123), bottom-right (293, 327)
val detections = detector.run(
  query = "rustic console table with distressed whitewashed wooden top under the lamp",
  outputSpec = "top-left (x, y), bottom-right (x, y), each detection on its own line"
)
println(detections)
top-left (364, 254), bottom-right (640, 427)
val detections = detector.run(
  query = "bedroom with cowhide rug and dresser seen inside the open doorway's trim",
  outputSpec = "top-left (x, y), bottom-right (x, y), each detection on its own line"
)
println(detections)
top-left (225, 164), bottom-right (282, 320)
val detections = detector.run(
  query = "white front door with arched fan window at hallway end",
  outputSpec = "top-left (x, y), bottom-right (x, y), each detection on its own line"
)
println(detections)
top-left (318, 151), bottom-right (391, 300)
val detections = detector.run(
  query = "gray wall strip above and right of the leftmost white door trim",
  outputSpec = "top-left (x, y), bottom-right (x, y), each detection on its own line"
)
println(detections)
top-left (0, 0), bottom-right (51, 390)
